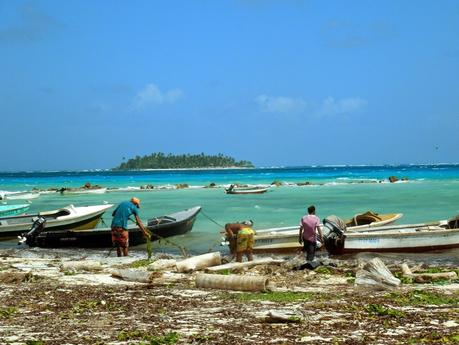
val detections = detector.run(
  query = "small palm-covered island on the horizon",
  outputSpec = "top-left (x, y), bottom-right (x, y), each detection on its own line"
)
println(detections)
top-left (113, 152), bottom-right (254, 170)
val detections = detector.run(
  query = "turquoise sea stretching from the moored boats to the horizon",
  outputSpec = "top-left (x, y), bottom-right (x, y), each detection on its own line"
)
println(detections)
top-left (0, 164), bottom-right (459, 262)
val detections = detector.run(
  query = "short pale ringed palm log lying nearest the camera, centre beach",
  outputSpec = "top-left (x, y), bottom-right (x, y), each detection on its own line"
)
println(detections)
top-left (196, 273), bottom-right (268, 291)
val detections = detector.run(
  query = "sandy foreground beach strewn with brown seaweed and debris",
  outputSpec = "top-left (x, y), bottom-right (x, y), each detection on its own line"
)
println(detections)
top-left (0, 250), bottom-right (459, 345)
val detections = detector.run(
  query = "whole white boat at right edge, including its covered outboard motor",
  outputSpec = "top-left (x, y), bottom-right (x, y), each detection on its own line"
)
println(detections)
top-left (324, 216), bottom-right (459, 255)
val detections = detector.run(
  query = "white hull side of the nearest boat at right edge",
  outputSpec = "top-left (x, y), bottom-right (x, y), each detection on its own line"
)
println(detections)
top-left (325, 226), bottom-right (459, 255)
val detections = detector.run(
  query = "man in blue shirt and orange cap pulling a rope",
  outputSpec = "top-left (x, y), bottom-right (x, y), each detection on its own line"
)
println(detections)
top-left (111, 198), bottom-right (151, 256)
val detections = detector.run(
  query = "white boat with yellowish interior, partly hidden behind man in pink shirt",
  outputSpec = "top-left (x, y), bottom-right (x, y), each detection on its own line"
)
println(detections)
top-left (253, 211), bottom-right (403, 253)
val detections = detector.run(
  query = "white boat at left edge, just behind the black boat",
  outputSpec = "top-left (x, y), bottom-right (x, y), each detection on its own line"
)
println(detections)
top-left (0, 204), bottom-right (113, 238)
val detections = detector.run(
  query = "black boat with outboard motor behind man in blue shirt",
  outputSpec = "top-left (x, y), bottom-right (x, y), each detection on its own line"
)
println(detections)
top-left (20, 206), bottom-right (201, 248)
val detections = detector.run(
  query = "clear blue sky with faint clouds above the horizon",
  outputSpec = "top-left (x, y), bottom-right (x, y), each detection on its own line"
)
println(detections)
top-left (0, 0), bottom-right (459, 171)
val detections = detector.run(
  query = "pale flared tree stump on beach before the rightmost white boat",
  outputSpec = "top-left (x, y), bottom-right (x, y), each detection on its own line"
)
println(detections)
top-left (355, 258), bottom-right (400, 290)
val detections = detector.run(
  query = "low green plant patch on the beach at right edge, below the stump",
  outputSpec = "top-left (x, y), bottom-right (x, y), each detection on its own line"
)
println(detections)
top-left (387, 290), bottom-right (459, 305)
